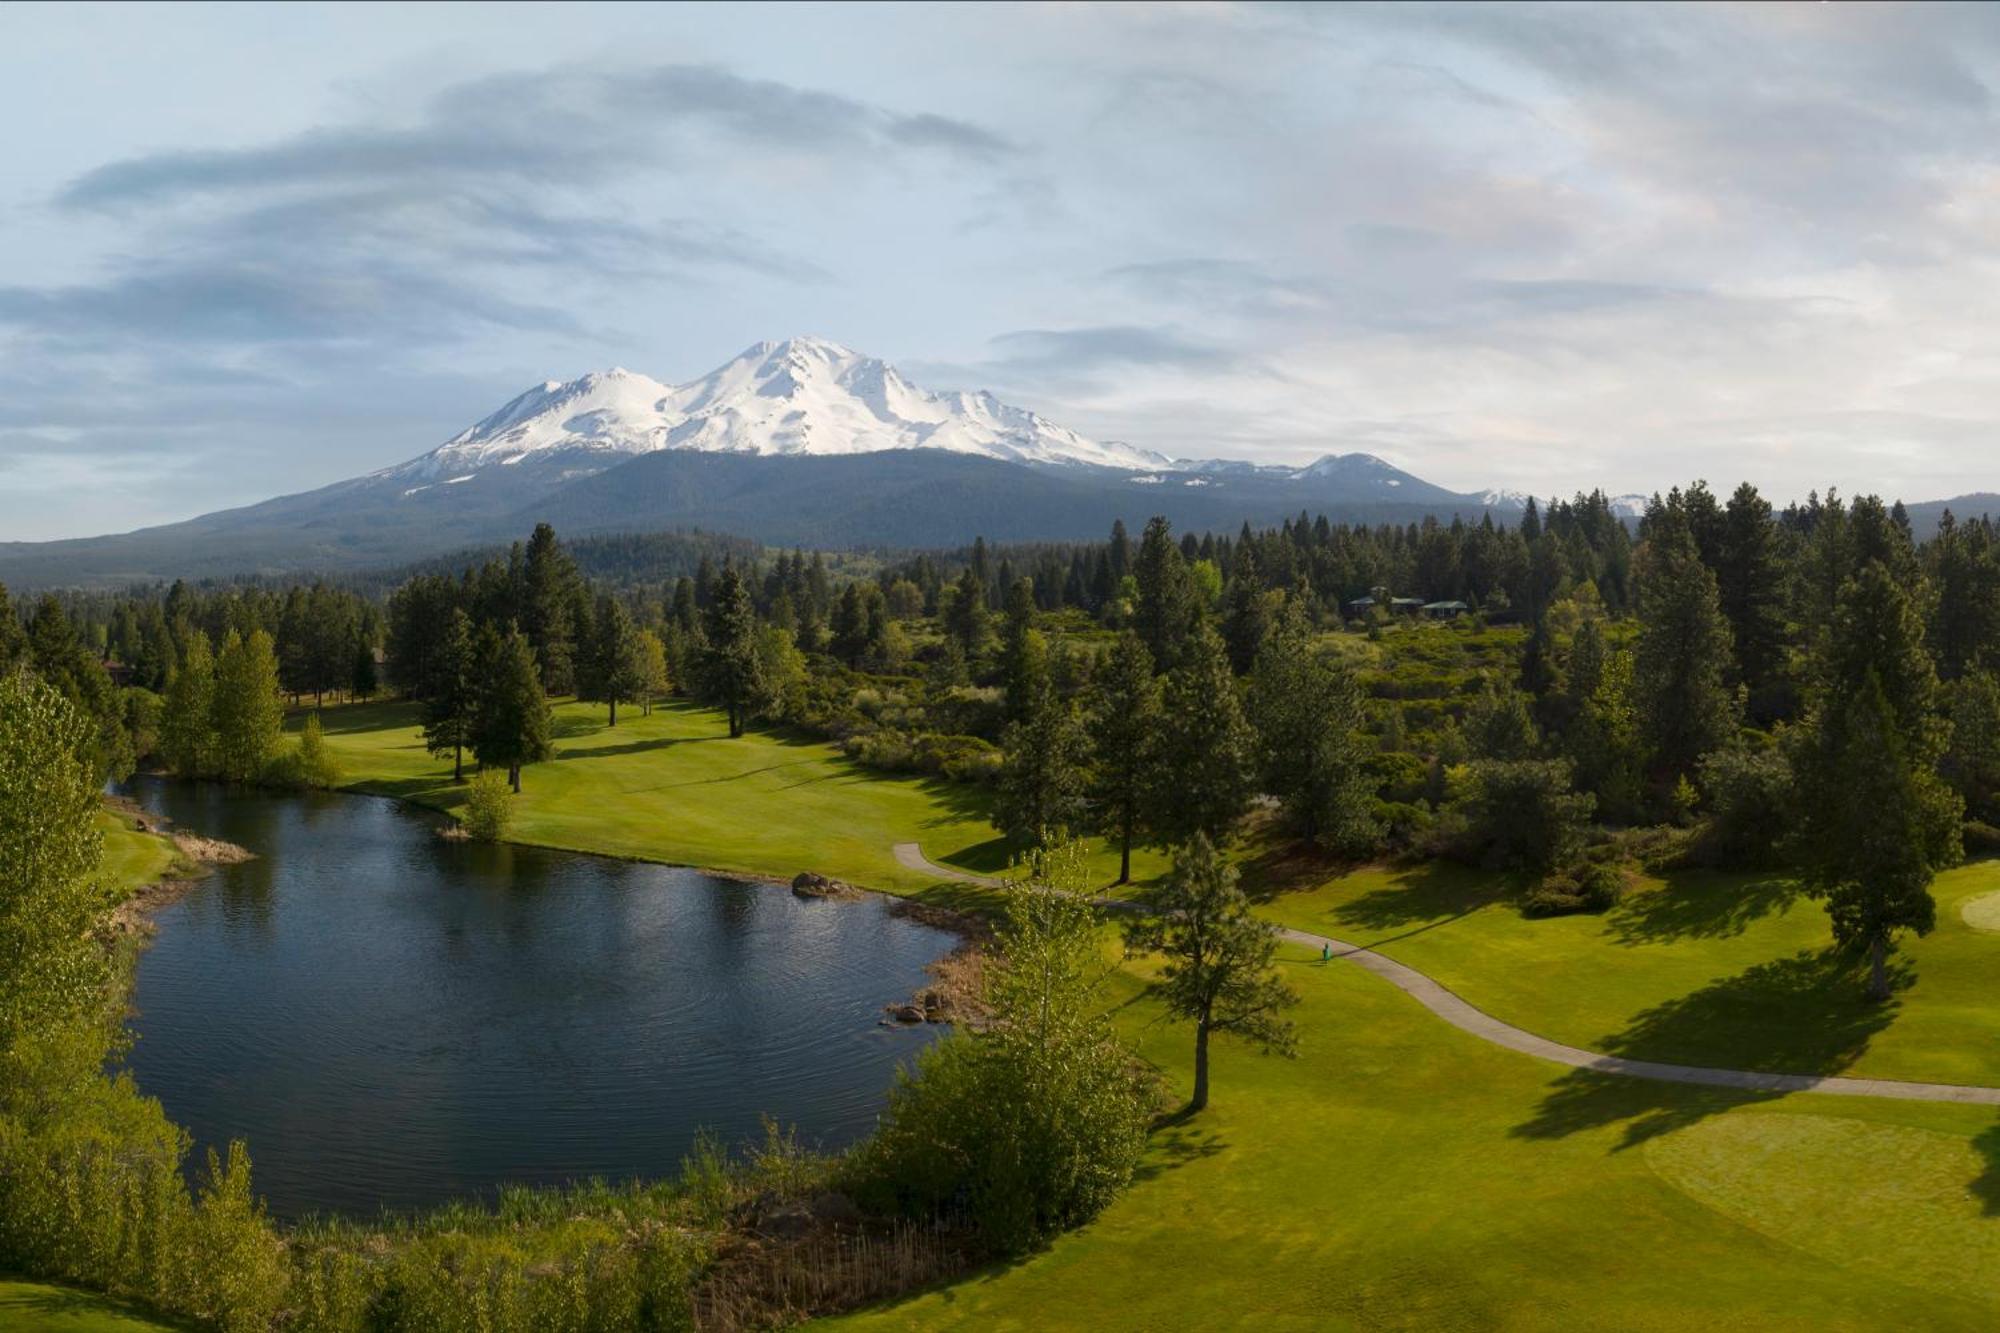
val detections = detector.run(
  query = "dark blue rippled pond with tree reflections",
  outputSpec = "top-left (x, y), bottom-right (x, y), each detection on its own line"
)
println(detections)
top-left (130, 779), bottom-right (952, 1217)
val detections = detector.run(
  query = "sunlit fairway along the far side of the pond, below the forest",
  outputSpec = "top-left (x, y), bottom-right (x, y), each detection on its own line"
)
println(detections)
top-left (294, 703), bottom-right (1158, 893)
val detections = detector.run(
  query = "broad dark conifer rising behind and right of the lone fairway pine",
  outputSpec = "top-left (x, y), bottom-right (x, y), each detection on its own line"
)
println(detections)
top-left (1250, 598), bottom-right (1380, 855)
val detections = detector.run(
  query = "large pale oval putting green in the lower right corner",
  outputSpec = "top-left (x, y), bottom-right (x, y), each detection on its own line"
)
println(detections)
top-left (1646, 1115), bottom-right (2000, 1301)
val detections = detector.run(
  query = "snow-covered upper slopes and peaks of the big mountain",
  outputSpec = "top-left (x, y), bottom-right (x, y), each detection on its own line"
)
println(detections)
top-left (384, 338), bottom-right (1168, 482)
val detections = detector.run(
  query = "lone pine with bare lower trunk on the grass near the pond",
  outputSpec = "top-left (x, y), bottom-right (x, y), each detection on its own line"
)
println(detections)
top-left (1126, 833), bottom-right (1298, 1111)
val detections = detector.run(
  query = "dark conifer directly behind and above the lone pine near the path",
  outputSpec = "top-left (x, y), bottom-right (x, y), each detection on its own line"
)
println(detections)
top-left (1144, 624), bottom-right (1256, 847)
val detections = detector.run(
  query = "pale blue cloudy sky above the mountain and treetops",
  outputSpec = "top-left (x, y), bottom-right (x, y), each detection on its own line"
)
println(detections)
top-left (0, 4), bottom-right (2000, 540)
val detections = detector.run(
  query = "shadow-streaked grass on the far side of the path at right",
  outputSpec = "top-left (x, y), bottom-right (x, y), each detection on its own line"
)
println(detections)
top-left (1252, 861), bottom-right (2000, 1085)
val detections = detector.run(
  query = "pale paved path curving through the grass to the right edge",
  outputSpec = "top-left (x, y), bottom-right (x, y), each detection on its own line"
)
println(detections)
top-left (896, 843), bottom-right (2000, 1107)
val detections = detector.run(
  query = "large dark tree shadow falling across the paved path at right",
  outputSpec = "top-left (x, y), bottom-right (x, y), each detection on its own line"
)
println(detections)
top-left (1512, 949), bottom-right (1904, 1144)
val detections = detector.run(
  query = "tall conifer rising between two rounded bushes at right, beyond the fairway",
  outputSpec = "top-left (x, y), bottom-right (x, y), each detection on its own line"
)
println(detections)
top-left (1632, 518), bottom-right (1736, 783)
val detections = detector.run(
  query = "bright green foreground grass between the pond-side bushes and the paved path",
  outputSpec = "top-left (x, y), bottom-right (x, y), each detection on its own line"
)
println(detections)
top-left (846, 928), bottom-right (2000, 1331)
